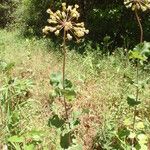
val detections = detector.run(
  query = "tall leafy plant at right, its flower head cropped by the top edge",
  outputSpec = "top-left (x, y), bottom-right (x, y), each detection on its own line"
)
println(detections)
top-left (114, 0), bottom-right (150, 150)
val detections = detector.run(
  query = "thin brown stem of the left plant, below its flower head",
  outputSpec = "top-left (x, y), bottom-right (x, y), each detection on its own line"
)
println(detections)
top-left (62, 30), bottom-right (68, 120)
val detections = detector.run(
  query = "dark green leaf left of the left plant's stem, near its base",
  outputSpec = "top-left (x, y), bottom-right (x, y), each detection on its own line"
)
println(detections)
top-left (48, 115), bottom-right (65, 128)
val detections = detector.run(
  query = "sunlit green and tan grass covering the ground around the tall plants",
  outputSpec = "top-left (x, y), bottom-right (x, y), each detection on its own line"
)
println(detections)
top-left (0, 30), bottom-right (150, 150)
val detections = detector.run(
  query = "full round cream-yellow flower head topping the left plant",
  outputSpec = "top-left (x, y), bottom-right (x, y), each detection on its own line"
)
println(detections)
top-left (43, 3), bottom-right (89, 40)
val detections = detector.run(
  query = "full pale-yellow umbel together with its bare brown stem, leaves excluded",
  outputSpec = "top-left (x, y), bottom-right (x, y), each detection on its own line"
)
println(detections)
top-left (43, 3), bottom-right (89, 120)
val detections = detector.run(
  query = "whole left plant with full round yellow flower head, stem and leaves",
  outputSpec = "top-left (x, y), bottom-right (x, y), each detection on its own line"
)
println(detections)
top-left (43, 3), bottom-right (89, 148)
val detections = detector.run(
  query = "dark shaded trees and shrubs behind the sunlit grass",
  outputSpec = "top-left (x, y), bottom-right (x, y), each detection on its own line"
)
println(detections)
top-left (0, 0), bottom-right (150, 49)
